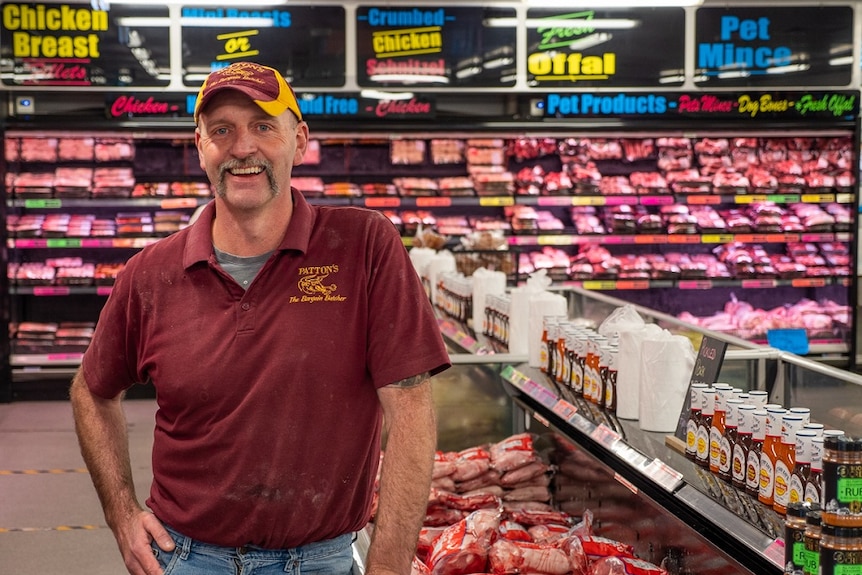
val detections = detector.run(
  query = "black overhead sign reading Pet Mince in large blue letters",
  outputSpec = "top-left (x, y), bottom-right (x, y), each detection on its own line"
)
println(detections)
top-left (694, 5), bottom-right (858, 86)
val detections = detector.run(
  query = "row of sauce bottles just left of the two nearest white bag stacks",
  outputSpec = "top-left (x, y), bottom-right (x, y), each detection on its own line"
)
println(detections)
top-left (539, 315), bottom-right (619, 412)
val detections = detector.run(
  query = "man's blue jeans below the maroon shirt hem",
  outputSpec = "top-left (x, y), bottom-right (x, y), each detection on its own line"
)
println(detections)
top-left (151, 525), bottom-right (353, 575)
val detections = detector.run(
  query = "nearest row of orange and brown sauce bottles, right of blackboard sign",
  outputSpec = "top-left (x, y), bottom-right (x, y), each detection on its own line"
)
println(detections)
top-left (686, 383), bottom-right (843, 514)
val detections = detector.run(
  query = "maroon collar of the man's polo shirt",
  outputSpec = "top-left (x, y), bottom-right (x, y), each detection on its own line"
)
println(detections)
top-left (183, 187), bottom-right (314, 268)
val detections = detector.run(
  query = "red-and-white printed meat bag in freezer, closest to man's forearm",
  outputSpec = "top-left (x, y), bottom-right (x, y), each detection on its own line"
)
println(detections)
top-left (427, 509), bottom-right (501, 575)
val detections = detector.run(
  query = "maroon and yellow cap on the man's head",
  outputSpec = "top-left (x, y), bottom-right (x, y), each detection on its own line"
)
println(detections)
top-left (195, 62), bottom-right (302, 124)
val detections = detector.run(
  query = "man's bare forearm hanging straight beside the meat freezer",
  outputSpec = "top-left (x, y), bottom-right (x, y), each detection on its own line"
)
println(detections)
top-left (366, 381), bottom-right (437, 574)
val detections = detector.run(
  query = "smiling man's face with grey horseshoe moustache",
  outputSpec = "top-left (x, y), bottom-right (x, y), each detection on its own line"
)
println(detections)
top-left (195, 90), bottom-right (308, 209)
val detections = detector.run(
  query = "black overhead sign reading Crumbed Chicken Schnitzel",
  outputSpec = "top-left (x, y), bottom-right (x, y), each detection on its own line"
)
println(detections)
top-left (356, 4), bottom-right (516, 88)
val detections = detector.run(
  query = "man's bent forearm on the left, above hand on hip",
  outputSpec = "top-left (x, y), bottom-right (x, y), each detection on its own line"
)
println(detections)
top-left (70, 372), bottom-right (140, 528)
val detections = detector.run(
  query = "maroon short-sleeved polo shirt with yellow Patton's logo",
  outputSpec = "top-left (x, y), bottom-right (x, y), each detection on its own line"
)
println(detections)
top-left (82, 190), bottom-right (449, 548)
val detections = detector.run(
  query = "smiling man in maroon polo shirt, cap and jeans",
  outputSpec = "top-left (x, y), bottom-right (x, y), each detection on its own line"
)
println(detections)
top-left (70, 62), bottom-right (449, 575)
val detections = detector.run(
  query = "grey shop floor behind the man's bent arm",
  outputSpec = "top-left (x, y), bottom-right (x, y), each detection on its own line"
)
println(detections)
top-left (0, 400), bottom-right (155, 575)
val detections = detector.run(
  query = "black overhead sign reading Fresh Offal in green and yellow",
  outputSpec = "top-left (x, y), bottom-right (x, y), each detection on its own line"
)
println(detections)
top-left (524, 8), bottom-right (685, 88)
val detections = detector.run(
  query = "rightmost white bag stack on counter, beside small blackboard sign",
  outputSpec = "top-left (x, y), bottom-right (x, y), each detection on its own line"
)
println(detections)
top-left (638, 330), bottom-right (695, 433)
